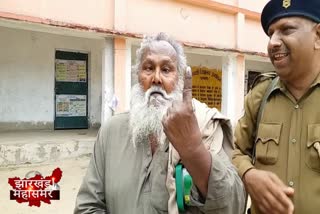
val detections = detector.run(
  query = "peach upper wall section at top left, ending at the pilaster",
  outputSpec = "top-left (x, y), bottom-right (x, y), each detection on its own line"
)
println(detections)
top-left (0, 0), bottom-right (114, 28)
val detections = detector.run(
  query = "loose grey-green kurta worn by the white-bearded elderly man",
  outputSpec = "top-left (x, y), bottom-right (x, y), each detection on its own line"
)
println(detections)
top-left (74, 113), bottom-right (245, 214)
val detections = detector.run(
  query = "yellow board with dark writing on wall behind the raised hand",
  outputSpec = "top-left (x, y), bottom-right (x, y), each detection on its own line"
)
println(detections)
top-left (191, 66), bottom-right (222, 110)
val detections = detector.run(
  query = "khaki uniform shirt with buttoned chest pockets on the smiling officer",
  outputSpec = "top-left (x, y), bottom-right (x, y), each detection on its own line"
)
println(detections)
top-left (233, 75), bottom-right (320, 214)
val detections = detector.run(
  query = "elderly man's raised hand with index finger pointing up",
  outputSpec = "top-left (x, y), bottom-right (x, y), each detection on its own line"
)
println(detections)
top-left (162, 67), bottom-right (201, 157)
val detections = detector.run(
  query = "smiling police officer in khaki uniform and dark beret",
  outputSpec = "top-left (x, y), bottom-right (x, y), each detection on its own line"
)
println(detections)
top-left (233, 0), bottom-right (320, 214)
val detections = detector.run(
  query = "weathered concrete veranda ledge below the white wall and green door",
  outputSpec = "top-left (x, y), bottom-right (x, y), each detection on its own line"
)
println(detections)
top-left (0, 129), bottom-right (97, 167)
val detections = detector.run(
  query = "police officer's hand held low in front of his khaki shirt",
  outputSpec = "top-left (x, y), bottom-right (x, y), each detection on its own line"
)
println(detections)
top-left (243, 169), bottom-right (294, 214)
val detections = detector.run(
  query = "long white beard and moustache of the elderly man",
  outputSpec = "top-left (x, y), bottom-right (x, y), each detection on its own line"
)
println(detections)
top-left (129, 84), bottom-right (182, 147)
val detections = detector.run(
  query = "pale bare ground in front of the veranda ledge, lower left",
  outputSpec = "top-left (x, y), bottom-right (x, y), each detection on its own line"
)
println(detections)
top-left (0, 156), bottom-right (90, 214)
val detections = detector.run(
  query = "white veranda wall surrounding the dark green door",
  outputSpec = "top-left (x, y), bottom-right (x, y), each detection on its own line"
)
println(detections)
top-left (0, 27), bottom-right (109, 129)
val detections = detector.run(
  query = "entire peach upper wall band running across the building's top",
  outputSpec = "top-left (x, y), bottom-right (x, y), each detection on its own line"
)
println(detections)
top-left (0, 0), bottom-right (268, 53)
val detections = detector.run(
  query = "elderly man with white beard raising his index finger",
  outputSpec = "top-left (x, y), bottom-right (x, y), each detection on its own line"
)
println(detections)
top-left (75, 33), bottom-right (245, 214)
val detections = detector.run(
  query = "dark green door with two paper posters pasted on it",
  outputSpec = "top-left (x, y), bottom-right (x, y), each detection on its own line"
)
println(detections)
top-left (54, 51), bottom-right (88, 129)
